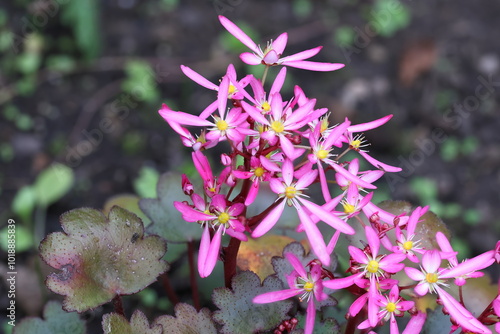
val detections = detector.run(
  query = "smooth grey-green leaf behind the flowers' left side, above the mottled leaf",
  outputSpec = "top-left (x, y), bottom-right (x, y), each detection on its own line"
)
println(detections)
top-left (139, 172), bottom-right (202, 242)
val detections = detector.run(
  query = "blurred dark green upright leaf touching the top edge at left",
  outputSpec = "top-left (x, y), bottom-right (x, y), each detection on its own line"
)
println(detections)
top-left (61, 0), bottom-right (101, 60)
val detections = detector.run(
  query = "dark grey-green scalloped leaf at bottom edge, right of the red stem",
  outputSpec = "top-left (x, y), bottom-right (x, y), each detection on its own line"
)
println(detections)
top-left (212, 271), bottom-right (293, 334)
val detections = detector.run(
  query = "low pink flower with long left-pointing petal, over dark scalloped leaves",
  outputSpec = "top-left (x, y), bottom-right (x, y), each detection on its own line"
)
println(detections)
top-left (253, 253), bottom-right (328, 334)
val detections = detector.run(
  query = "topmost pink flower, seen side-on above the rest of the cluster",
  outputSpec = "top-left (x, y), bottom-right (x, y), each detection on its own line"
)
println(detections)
top-left (219, 15), bottom-right (345, 71)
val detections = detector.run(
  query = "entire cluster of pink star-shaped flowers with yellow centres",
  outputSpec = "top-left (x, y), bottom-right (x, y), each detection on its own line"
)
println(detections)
top-left (159, 16), bottom-right (500, 333)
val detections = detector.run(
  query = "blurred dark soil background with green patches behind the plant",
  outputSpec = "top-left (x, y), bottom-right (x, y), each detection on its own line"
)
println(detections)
top-left (0, 0), bottom-right (500, 328)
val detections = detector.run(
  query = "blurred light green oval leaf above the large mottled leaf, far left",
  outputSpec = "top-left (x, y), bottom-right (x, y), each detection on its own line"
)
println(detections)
top-left (34, 163), bottom-right (75, 207)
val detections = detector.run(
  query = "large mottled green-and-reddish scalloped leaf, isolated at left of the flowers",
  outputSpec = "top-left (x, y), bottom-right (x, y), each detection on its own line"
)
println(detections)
top-left (40, 206), bottom-right (168, 312)
